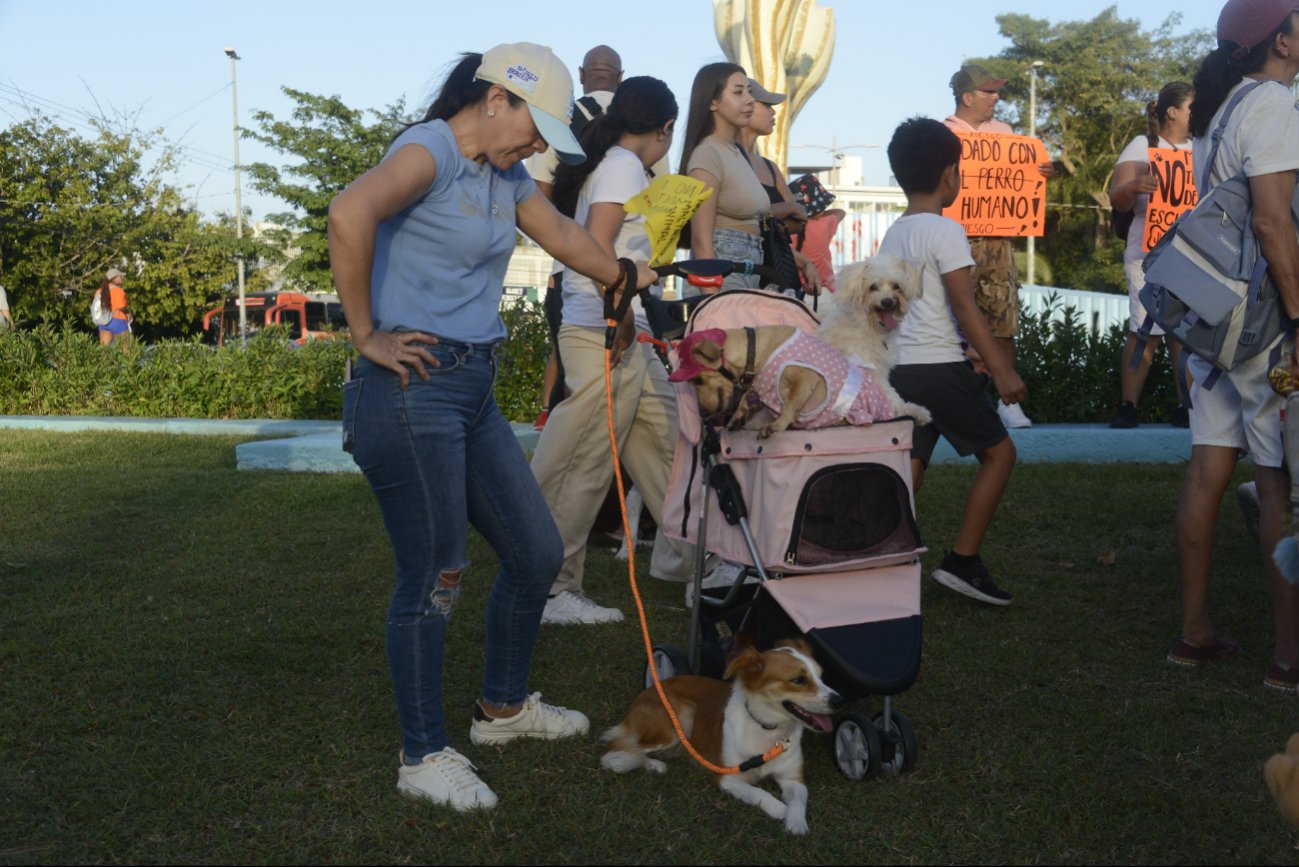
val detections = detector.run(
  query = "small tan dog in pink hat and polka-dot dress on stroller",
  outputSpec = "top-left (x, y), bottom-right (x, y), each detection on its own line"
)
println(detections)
top-left (668, 325), bottom-right (894, 437)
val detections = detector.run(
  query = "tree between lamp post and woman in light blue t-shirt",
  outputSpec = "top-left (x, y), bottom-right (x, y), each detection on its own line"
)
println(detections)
top-left (243, 87), bottom-right (408, 292)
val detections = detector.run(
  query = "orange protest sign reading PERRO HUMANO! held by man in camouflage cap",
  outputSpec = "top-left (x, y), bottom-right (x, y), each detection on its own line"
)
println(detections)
top-left (943, 133), bottom-right (1048, 238)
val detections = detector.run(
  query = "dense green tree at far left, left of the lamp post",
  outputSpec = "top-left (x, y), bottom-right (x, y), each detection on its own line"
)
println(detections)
top-left (0, 114), bottom-right (256, 339)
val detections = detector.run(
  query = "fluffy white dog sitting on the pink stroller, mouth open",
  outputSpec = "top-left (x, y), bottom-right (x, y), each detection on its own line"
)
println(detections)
top-left (816, 256), bottom-right (930, 425)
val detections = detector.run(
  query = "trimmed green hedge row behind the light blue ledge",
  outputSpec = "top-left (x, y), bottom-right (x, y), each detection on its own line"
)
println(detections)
top-left (0, 298), bottom-right (1176, 422)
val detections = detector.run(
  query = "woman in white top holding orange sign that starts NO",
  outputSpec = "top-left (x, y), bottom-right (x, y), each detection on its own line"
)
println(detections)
top-left (1109, 82), bottom-right (1195, 428)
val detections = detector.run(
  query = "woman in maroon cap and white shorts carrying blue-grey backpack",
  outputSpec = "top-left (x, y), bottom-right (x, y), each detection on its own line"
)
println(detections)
top-left (1168, 0), bottom-right (1299, 701)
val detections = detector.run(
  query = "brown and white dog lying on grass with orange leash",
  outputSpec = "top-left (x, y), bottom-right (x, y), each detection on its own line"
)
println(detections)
top-left (600, 641), bottom-right (843, 835)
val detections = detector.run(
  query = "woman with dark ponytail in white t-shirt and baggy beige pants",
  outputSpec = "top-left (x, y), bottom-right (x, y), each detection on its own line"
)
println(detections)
top-left (533, 75), bottom-right (690, 624)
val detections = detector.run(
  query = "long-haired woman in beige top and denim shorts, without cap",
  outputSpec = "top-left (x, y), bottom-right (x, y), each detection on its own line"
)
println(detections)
top-left (681, 64), bottom-right (770, 290)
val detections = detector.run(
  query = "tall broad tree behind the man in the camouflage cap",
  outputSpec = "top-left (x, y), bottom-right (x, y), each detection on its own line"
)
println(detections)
top-left (974, 6), bottom-right (1213, 291)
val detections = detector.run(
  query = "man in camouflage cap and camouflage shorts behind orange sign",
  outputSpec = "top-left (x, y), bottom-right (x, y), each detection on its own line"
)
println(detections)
top-left (943, 64), bottom-right (1055, 428)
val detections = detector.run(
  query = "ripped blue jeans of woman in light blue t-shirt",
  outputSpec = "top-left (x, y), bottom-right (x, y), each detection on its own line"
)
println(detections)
top-left (343, 342), bottom-right (564, 759)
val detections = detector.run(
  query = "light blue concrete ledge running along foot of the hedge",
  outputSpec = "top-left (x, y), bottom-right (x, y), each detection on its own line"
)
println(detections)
top-left (0, 416), bottom-right (1191, 473)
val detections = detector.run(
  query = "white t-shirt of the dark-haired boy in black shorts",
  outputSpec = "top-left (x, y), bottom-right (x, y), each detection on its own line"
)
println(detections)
top-left (879, 213), bottom-right (974, 364)
